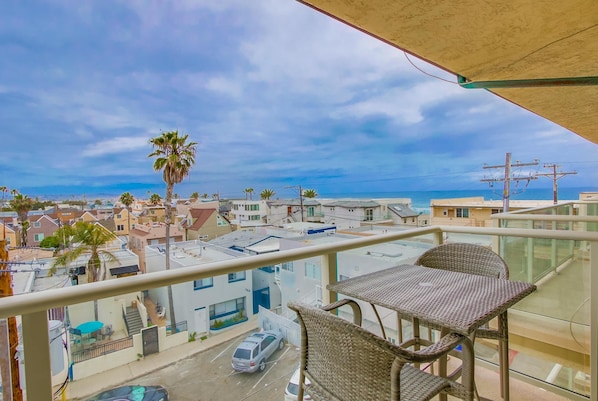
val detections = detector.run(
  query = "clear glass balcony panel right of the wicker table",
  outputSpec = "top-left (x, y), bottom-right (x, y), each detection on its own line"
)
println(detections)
top-left (496, 233), bottom-right (590, 396)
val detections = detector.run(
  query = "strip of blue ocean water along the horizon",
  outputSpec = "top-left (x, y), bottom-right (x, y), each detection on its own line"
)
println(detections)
top-left (318, 187), bottom-right (598, 213)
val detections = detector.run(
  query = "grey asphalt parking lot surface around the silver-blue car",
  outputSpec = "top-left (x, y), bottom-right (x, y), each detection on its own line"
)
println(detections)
top-left (128, 335), bottom-right (299, 401)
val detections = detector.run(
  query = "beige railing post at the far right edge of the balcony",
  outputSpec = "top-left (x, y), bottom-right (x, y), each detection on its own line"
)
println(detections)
top-left (590, 241), bottom-right (598, 401)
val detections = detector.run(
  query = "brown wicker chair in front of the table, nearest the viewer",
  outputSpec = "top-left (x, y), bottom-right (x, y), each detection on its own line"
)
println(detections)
top-left (288, 299), bottom-right (473, 401)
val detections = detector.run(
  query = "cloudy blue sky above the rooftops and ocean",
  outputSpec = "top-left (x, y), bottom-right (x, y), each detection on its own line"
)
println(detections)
top-left (0, 0), bottom-right (598, 197)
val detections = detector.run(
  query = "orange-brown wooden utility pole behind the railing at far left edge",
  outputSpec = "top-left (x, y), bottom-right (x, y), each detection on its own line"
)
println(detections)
top-left (0, 239), bottom-right (23, 401)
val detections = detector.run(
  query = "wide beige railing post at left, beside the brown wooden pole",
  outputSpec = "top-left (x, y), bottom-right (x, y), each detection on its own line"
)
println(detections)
top-left (22, 311), bottom-right (52, 401)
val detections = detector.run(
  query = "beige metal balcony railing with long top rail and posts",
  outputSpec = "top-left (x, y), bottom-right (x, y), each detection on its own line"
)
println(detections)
top-left (0, 223), bottom-right (598, 401)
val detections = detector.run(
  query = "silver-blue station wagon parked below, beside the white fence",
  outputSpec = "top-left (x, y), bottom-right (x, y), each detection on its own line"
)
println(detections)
top-left (232, 330), bottom-right (284, 372)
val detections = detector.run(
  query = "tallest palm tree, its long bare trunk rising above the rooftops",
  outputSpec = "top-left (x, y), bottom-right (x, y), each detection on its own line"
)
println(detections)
top-left (148, 130), bottom-right (197, 333)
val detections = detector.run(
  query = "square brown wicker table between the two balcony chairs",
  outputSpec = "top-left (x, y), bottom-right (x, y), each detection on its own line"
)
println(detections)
top-left (326, 265), bottom-right (536, 401)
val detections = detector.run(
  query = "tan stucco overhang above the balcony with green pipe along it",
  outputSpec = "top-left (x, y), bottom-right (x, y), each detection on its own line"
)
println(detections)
top-left (299, 0), bottom-right (598, 144)
